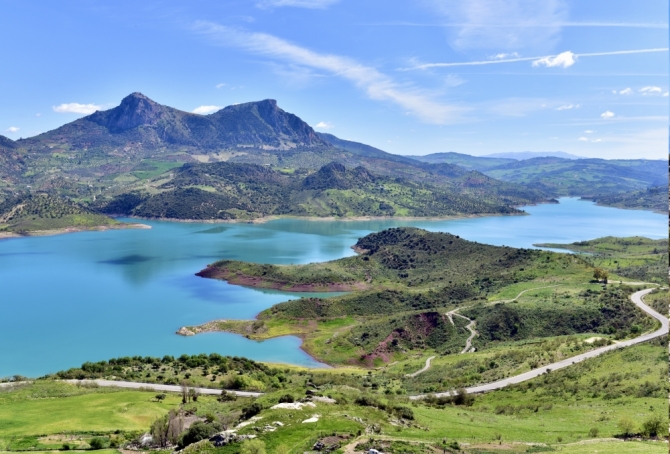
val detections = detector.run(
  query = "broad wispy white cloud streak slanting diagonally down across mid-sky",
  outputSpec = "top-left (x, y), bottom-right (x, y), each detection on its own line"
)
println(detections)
top-left (193, 21), bottom-right (467, 124)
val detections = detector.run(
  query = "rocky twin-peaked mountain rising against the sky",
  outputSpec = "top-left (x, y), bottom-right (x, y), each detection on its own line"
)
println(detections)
top-left (22, 93), bottom-right (326, 152)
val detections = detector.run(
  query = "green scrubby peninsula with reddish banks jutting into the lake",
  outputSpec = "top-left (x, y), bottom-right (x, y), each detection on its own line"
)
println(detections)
top-left (192, 228), bottom-right (653, 367)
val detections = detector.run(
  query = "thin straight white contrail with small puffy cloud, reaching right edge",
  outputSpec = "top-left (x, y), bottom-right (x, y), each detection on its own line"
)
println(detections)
top-left (400, 47), bottom-right (670, 71)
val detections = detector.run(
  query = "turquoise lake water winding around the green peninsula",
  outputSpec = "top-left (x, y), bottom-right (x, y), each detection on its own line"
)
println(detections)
top-left (0, 199), bottom-right (667, 377)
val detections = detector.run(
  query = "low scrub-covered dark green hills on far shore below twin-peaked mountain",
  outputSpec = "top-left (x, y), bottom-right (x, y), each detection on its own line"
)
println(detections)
top-left (93, 162), bottom-right (532, 220)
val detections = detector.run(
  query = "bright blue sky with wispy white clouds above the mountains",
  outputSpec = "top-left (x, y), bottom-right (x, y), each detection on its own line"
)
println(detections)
top-left (0, 0), bottom-right (669, 159)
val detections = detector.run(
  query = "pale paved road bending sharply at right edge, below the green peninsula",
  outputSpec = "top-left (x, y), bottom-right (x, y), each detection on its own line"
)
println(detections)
top-left (409, 289), bottom-right (668, 400)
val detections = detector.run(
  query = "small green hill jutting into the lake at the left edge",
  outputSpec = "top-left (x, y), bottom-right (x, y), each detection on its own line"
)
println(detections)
top-left (0, 194), bottom-right (126, 235)
